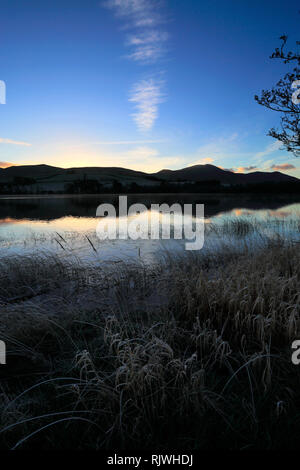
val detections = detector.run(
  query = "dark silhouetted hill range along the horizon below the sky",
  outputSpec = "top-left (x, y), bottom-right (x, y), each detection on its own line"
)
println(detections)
top-left (0, 165), bottom-right (300, 192)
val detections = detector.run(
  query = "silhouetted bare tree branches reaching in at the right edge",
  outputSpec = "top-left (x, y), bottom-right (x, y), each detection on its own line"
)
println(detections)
top-left (255, 35), bottom-right (300, 157)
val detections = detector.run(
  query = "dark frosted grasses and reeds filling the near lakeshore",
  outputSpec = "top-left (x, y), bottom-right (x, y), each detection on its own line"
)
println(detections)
top-left (0, 239), bottom-right (300, 450)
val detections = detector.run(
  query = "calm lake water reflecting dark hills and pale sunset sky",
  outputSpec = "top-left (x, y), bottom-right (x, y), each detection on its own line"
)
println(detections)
top-left (0, 194), bottom-right (300, 261)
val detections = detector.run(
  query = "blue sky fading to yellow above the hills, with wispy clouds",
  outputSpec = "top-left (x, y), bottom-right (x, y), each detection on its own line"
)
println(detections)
top-left (0, 0), bottom-right (300, 177)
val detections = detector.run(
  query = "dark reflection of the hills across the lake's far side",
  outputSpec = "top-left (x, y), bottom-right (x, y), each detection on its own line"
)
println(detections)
top-left (0, 194), bottom-right (300, 221)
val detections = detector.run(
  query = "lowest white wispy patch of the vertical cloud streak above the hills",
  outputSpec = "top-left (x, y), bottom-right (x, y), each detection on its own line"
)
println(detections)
top-left (129, 78), bottom-right (164, 131)
